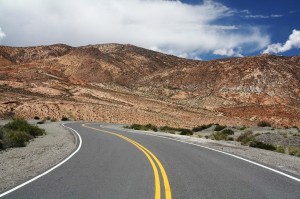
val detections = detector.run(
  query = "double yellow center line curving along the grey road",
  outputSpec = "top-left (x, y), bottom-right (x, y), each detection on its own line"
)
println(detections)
top-left (82, 124), bottom-right (172, 199)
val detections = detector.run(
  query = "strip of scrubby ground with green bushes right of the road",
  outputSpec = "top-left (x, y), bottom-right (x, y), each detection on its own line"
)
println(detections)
top-left (125, 121), bottom-right (300, 157)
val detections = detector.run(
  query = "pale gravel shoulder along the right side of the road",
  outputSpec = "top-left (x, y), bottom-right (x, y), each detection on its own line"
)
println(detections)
top-left (107, 125), bottom-right (300, 176)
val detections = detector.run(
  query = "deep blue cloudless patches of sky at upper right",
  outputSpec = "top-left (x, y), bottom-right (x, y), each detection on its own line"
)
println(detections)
top-left (188, 0), bottom-right (300, 58)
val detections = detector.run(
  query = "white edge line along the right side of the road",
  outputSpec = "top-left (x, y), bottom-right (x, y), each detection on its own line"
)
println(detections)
top-left (111, 125), bottom-right (300, 182)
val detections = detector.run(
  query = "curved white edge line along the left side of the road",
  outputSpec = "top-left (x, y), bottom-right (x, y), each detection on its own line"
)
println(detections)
top-left (0, 124), bottom-right (82, 198)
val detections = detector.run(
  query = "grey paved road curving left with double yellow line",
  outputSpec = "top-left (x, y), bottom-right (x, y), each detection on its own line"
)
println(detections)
top-left (3, 123), bottom-right (300, 199)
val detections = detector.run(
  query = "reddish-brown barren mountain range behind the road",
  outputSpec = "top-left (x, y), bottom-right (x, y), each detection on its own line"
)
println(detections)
top-left (0, 44), bottom-right (300, 127)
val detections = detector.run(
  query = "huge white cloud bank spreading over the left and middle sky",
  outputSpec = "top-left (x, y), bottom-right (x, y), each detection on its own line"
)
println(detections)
top-left (0, 0), bottom-right (270, 57)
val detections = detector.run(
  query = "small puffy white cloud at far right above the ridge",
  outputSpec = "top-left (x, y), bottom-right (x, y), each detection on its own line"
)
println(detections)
top-left (263, 30), bottom-right (300, 53)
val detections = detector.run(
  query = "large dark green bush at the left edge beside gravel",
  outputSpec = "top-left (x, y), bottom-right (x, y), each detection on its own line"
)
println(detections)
top-left (0, 118), bottom-right (46, 150)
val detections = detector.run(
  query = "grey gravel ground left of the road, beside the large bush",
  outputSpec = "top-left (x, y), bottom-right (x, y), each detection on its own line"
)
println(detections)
top-left (0, 121), bottom-right (76, 192)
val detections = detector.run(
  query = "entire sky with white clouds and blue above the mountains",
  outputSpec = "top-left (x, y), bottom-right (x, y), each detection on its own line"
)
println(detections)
top-left (0, 0), bottom-right (300, 60)
